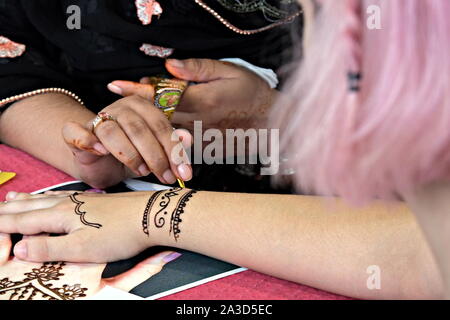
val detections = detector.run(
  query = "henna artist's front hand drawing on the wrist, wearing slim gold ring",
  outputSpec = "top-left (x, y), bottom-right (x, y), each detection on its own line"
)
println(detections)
top-left (63, 96), bottom-right (192, 187)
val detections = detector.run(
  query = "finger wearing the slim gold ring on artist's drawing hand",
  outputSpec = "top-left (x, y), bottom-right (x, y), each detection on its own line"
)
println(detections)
top-left (95, 114), bottom-right (150, 176)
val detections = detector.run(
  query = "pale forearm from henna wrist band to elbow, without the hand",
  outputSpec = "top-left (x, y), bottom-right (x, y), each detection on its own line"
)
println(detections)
top-left (143, 191), bottom-right (440, 298)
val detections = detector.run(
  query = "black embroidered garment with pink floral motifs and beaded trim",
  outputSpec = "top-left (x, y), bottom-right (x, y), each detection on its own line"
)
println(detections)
top-left (0, 0), bottom-right (302, 112)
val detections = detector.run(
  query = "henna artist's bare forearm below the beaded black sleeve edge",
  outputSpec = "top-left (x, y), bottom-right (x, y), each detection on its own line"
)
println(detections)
top-left (0, 93), bottom-right (95, 178)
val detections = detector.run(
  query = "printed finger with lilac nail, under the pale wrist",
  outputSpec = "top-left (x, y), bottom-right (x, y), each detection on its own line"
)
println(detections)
top-left (105, 251), bottom-right (181, 292)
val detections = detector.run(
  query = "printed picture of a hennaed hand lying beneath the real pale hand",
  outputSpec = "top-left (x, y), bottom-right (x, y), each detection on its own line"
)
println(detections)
top-left (0, 234), bottom-right (180, 300)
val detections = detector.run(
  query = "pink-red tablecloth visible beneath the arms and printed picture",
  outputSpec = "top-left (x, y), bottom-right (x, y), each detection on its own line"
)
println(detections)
top-left (0, 145), bottom-right (349, 300)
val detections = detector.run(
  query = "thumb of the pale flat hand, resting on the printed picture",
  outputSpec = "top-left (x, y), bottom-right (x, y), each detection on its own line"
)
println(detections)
top-left (14, 232), bottom-right (86, 263)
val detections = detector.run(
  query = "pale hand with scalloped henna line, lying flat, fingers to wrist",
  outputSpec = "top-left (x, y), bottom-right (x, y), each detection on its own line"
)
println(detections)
top-left (0, 192), bottom-right (159, 263)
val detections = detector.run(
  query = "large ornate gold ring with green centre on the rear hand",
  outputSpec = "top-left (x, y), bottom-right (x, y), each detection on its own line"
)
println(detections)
top-left (150, 77), bottom-right (188, 120)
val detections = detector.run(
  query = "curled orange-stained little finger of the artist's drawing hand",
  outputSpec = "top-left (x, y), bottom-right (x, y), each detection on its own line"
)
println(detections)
top-left (62, 122), bottom-right (109, 157)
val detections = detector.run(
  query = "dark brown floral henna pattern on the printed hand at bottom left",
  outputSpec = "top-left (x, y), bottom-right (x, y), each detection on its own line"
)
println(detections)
top-left (0, 262), bottom-right (88, 300)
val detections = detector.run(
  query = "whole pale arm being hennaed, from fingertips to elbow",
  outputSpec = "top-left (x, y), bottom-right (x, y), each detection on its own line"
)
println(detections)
top-left (0, 190), bottom-right (441, 299)
